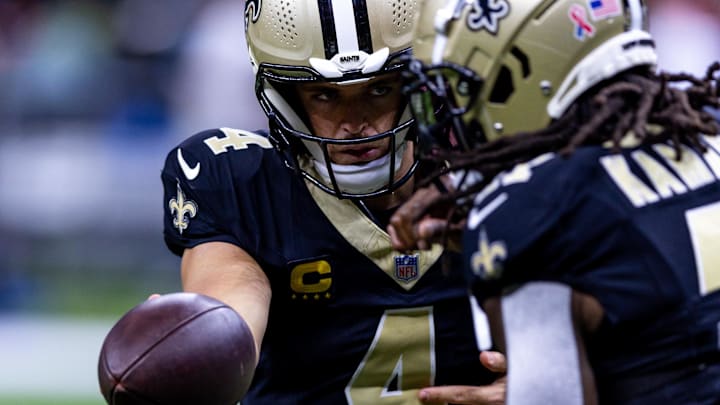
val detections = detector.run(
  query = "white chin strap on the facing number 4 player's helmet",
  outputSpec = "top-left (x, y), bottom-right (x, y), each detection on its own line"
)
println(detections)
top-left (263, 81), bottom-right (411, 194)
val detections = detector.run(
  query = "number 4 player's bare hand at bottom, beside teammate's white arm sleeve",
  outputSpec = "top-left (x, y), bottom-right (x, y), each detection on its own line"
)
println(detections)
top-left (418, 351), bottom-right (507, 405)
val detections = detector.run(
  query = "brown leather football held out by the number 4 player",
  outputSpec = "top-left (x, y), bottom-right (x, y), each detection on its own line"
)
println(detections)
top-left (98, 292), bottom-right (255, 405)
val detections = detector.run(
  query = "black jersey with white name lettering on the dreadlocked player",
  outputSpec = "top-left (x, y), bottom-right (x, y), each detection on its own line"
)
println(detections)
top-left (464, 137), bottom-right (720, 388)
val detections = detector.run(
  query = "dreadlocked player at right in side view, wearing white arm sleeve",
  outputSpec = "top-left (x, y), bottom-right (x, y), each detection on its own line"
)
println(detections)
top-left (390, 0), bottom-right (720, 404)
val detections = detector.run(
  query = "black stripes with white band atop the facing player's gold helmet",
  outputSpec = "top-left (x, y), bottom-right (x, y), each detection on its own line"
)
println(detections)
top-left (318, 0), bottom-right (373, 59)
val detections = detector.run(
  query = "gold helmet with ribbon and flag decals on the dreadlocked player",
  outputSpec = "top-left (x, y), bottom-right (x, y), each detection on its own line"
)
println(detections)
top-left (409, 0), bottom-right (657, 147)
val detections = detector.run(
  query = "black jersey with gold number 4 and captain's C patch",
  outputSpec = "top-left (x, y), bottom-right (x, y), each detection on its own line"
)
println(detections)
top-left (162, 128), bottom-right (491, 405)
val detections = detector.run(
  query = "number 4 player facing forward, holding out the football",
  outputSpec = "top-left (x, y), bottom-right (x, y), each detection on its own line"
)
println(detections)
top-left (162, 0), bottom-right (504, 405)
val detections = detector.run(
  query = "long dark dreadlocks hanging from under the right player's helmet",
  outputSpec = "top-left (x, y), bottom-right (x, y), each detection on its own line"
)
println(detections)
top-left (421, 62), bottom-right (720, 218)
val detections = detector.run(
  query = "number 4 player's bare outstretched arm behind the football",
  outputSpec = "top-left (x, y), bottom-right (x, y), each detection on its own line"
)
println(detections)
top-left (181, 242), bottom-right (272, 364)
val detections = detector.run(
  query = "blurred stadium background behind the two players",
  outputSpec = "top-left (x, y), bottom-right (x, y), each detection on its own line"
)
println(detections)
top-left (0, 0), bottom-right (720, 405)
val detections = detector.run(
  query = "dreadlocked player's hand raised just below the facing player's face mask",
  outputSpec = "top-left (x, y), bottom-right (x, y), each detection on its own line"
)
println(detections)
top-left (387, 181), bottom-right (465, 251)
